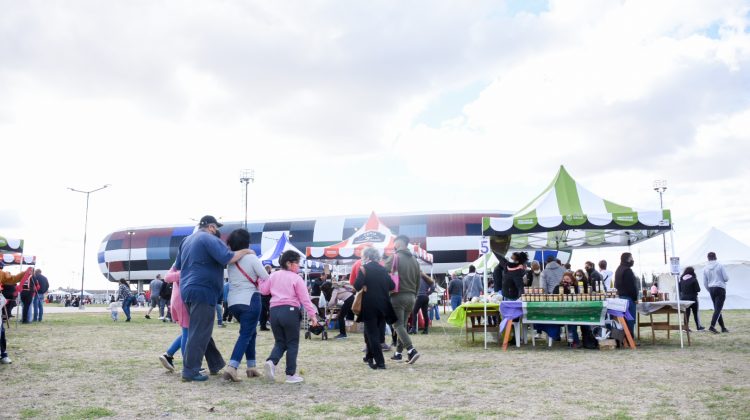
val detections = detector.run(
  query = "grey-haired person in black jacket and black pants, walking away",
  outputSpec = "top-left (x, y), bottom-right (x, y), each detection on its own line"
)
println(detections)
top-left (354, 248), bottom-right (396, 369)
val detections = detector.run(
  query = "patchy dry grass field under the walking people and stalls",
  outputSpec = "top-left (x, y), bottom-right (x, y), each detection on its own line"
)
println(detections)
top-left (0, 311), bottom-right (750, 419)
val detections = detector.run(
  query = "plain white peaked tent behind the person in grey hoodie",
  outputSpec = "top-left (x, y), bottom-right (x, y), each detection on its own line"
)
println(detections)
top-left (681, 228), bottom-right (750, 309)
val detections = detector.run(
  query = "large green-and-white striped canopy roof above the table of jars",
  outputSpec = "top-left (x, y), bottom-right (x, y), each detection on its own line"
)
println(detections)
top-left (482, 166), bottom-right (672, 250)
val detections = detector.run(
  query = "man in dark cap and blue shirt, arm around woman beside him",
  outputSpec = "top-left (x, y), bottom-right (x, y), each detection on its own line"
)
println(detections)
top-left (175, 216), bottom-right (251, 382)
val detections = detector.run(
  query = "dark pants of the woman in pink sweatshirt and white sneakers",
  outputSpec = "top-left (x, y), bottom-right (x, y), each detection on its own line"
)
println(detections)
top-left (266, 305), bottom-right (301, 376)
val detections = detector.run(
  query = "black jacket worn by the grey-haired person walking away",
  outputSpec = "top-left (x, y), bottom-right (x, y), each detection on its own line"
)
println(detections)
top-left (354, 262), bottom-right (396, 324)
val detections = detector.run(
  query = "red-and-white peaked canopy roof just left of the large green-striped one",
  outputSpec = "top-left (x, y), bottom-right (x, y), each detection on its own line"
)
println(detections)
top-left (307, 212), bottom-right (432, 264)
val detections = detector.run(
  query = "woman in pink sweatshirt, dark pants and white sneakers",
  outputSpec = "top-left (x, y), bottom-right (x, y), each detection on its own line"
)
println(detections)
top-left (260, 250), bottom-right (318, 384)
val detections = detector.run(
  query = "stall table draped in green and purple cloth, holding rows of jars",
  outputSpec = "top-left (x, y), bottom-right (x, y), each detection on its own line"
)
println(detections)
top-left (500, 299), bottom-right (635, 350)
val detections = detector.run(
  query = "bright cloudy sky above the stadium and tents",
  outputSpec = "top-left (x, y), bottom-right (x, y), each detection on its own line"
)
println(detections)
top-left (0, 0), bottom-right (750, 288)
